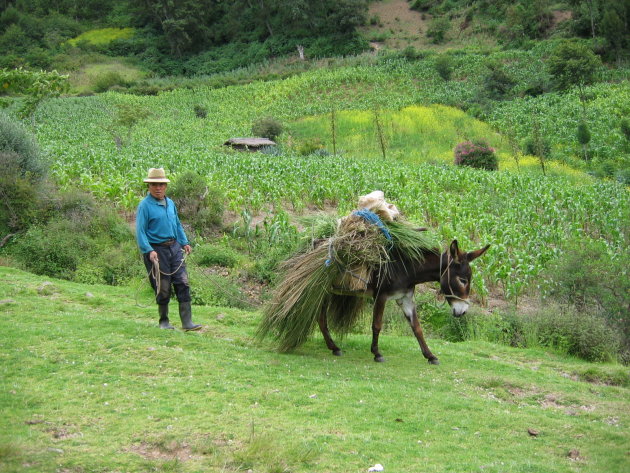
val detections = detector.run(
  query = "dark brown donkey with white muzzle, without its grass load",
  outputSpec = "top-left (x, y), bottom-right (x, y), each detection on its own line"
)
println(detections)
top-left (318, 240), bottom-right (490, 365)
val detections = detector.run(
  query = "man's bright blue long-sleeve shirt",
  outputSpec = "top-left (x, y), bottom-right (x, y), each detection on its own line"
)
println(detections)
top-left (136, 194), bottom-right (189, 253)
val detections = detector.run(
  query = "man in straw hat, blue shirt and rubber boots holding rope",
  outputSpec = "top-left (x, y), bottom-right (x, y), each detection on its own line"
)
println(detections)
top-left (136, 168), bottom-right (201, 331)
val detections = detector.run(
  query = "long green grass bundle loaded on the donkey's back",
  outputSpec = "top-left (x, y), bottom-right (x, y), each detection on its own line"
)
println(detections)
top-left (256, 192), bottom-right (436, 352)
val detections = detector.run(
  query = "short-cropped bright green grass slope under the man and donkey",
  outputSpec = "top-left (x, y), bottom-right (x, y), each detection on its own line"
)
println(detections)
top-left (0, 268), bottom-right (630, 473)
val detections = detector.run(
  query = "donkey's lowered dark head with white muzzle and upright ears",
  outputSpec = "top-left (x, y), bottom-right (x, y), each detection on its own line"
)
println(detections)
top-left (440, 240), bottom-right (490, 317)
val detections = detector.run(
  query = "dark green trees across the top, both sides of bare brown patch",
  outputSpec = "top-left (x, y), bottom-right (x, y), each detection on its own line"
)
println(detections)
top-left (0, 0), bottom-right (630, 75)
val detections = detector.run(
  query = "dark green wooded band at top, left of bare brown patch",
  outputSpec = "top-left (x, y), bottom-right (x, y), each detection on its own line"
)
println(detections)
top-left (0, 0), bottom-right (368, 74)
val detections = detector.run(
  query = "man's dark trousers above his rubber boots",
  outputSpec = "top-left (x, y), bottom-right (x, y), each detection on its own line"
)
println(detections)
top-left (143, 242), bottom-right (191, 305)
